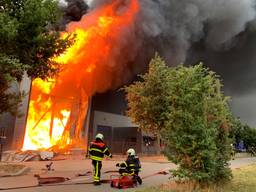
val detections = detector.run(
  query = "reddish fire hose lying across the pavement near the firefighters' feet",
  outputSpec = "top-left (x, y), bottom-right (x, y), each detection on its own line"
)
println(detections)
top-left (0, 170), bottom-right (168, 190)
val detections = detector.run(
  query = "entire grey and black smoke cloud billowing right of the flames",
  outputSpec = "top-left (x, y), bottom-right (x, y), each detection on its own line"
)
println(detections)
top-left (58, 0), bottom-right (256, 124)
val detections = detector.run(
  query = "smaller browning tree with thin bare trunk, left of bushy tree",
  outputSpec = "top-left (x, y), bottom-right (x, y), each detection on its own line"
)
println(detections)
top-left (125, 54), bottom-right (170, 151)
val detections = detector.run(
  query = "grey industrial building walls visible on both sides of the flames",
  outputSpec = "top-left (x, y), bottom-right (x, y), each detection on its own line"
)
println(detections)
top-left (0, 77), bottom-right (156, 154)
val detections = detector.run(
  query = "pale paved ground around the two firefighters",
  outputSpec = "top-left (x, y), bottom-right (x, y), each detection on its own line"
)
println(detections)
top-left (0, 158), bottom-right (256, 192)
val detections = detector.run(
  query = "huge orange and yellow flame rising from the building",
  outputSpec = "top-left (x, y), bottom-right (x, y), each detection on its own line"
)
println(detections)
top-left (23, 0), bottom-right (139, 150)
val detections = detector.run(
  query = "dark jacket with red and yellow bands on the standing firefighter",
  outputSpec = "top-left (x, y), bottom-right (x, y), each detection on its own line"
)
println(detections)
top-left (89, 139), bottom-right (112, 161)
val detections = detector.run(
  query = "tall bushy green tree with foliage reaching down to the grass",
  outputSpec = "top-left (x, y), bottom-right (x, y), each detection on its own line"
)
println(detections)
top-left (162, 64), bottom-right (234, 184)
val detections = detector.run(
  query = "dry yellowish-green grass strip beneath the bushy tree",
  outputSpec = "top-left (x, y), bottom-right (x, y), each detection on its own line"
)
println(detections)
top-left (136, 164), bottom-right (256, 192)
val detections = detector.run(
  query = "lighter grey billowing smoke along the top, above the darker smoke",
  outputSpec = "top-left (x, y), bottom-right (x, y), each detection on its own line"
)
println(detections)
top-left (87, 0), bottom-right (256, 64)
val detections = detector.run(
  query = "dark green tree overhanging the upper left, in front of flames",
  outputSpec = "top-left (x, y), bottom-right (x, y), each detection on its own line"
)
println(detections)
top-left (0, 0), bottom-right (73, 113)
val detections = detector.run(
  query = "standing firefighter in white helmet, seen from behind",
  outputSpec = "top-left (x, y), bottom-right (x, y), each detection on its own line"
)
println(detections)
top-left (89, 133), bottom-right (112, 185)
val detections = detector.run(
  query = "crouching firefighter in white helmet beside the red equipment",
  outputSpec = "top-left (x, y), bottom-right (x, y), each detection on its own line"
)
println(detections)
top-left (116, 148), bottom-right (142, 185)
